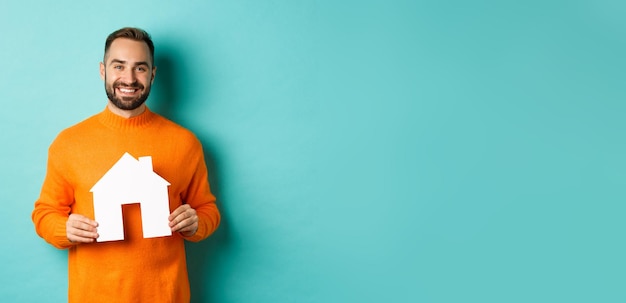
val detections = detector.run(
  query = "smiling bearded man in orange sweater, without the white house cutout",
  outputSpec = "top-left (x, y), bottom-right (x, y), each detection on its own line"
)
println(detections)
top-left (32, 28), bottom-right (220, 302)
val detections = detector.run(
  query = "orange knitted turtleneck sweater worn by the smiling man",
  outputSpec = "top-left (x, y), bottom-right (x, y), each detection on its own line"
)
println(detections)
top-left (32, 109), bottom-right (220, 302)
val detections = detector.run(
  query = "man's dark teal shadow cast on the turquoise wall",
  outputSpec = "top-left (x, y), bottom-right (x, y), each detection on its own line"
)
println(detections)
top-left (148, 45), bottom-right (230, 302)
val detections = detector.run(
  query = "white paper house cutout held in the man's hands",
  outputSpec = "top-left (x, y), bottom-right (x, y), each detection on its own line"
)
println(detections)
top-left (90, 153), bottom-right (172, 242)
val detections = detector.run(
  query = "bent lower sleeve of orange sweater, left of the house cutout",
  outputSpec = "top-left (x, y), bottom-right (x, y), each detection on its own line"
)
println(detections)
top-left (32, 143), bottom-right (74, 249)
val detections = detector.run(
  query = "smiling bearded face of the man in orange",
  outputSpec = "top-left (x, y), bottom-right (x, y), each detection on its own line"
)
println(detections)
top-left (100, 38), bottom-right (156, 110)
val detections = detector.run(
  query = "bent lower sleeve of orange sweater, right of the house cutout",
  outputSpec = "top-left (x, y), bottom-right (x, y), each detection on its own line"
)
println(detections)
top-left (183, 142), bottom-right (220, 242)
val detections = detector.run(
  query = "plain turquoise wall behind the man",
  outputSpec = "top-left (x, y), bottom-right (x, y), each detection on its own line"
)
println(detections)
top-left (0, 0), bottom-right (626, 302)
